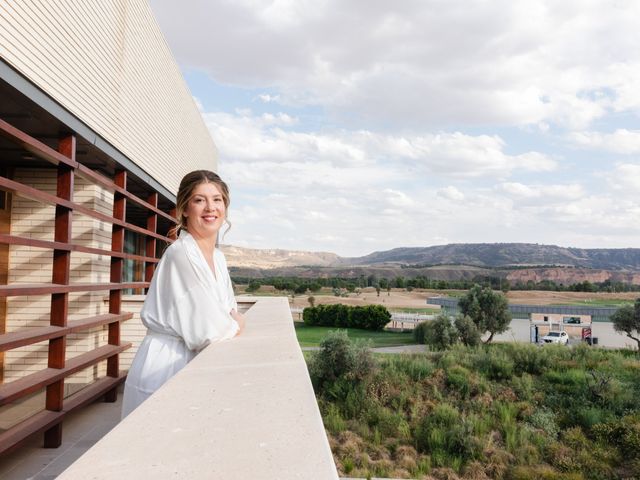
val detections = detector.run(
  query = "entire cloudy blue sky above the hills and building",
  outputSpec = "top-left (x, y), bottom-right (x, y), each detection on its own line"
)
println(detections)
top-left (151, 0), bottom-right (640, 256)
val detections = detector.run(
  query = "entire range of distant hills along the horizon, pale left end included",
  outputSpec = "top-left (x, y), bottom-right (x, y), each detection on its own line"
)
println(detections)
top-left (221, 243), bottom-right (640, 285)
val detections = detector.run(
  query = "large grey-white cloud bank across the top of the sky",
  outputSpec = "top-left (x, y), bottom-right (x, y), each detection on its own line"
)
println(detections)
top-left (152, 0), bottom-right (640, 129)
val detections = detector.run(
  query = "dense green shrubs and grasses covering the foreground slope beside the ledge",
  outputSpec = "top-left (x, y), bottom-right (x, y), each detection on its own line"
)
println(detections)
top-left (309, 335), bottom-right (640, 480)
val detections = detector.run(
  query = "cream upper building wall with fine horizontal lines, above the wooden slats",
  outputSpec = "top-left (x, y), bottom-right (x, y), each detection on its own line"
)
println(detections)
top-left (0, 0), bottom-right (217, 192)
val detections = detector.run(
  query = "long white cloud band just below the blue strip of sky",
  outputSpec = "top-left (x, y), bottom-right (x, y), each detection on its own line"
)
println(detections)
top-left (204, 111), bottom-right (557, 179)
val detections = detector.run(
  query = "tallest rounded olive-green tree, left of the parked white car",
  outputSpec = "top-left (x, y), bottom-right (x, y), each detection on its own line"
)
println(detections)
top-left (458, 284), bottom-right (511, 343)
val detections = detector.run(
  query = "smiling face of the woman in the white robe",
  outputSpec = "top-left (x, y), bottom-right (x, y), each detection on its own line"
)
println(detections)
top-left (183, 183), bottom-right (227, 238)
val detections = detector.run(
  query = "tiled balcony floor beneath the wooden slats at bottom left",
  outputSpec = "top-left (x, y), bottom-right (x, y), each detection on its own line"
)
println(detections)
top-left (0, 392), bottom-right (122, 480)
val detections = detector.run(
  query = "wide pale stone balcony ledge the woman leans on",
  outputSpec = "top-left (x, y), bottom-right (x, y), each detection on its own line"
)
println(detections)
top-left (58, 298), bottom-right (338, 480)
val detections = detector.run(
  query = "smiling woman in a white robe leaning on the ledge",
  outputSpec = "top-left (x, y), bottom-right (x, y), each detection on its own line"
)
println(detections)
top-left (122, 170), bottom-right (244, 418)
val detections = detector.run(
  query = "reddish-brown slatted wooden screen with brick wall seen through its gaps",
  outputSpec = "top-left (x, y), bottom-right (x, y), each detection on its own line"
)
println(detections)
top-left (0, 116), bottom-right (175, 455)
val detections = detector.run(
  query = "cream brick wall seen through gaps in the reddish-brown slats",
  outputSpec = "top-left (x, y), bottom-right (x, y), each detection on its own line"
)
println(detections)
top-left (4, 169), bottom-right (113, 393)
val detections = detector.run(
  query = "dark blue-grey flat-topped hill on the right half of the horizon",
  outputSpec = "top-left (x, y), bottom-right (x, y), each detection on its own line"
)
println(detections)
top-left (345, 243), bottom-right (640, 271)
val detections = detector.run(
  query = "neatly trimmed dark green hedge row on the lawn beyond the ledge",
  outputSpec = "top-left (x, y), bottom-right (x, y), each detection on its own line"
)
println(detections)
top-left (302, 303), bottom-right (391, 330)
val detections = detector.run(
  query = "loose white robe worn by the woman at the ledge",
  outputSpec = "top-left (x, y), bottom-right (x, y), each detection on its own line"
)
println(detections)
top-left (122, 231), bottom-right (238, 418)
